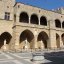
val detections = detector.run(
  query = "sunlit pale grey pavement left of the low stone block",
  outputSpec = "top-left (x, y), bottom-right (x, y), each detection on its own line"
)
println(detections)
top-left (0, 52), bottom-right (52, 64)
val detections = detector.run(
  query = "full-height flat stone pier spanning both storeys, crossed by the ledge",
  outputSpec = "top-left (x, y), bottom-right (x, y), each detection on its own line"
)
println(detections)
top-left (48, 20), bottom-right (57, 49)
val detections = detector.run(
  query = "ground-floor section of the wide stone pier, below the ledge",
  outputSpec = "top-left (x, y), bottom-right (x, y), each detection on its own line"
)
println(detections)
top-left (48, 30), bottom-right (57, 49)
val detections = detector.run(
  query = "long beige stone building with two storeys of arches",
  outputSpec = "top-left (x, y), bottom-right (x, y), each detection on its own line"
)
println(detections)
top-left (0, 0), bottom-right (64, 50)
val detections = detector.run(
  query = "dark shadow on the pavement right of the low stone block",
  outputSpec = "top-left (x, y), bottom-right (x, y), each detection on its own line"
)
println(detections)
top-left (41, 52), bottom-right (64, 64)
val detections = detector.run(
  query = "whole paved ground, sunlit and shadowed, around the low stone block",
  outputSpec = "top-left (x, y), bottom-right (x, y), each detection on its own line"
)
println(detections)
top-left (0, 52), bottom-right (64, 64)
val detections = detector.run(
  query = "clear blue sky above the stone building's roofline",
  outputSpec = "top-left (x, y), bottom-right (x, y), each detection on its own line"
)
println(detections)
top-left (16, 0), bottom-right (64, 10)
